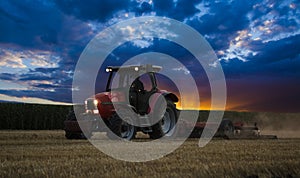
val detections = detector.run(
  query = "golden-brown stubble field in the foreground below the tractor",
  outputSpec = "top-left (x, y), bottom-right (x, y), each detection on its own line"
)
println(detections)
top-left (0, 130), bottom-right (300, 177)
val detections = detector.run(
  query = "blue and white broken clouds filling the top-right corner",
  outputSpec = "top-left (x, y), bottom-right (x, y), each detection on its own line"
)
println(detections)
top-left (186, 1), bottom-right (300, 67)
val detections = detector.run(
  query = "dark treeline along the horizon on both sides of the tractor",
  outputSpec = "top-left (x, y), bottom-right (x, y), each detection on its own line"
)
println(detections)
top-left (0, 103), bottom-right (300, 130)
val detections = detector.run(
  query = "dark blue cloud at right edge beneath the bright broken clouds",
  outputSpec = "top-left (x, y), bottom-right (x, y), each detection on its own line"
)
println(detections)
top-left (221, 40), bottom-right (300, 80)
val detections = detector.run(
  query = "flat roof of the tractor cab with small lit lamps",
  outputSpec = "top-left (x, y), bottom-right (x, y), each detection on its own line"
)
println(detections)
top-left (106, 64), bottom-right (162, 72)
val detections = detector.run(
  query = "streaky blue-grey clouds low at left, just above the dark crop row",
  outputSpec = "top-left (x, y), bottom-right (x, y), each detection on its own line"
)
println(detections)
top-left (0, 68), bottom-right (72, 102)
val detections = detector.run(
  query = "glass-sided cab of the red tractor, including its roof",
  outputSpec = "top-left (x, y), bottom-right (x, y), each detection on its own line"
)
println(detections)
top-left (106, 65), bottom-right (162, 115)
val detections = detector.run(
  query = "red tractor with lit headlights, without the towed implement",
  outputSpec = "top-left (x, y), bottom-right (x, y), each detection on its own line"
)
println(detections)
top-left (64, 65), bottom-right (178, 140)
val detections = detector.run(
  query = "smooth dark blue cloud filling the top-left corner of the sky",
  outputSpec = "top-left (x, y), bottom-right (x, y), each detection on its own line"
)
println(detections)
top-left (0, 0), bottom-right (93, 58)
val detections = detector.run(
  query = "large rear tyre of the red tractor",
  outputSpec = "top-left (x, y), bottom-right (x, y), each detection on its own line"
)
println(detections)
top-left (149, 100), bottom-right (178, 139)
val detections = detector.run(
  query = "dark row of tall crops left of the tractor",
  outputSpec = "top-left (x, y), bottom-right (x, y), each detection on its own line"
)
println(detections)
top-left (0, 103), bottom-right (72, 130)
